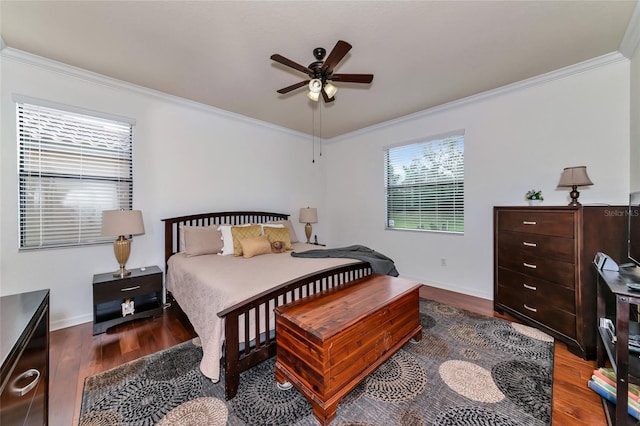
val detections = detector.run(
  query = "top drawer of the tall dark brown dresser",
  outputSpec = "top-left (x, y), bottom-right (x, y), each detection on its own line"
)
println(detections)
top-left (498, 210), bottom-right (574, 238)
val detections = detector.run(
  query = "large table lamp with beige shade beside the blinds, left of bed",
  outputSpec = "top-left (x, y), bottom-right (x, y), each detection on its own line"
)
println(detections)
top-left (102, 210), bottom-right (144, 278)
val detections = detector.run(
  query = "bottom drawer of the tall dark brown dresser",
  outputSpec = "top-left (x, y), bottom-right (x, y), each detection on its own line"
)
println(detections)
top-left (498, 286), bottom-right (576, 339)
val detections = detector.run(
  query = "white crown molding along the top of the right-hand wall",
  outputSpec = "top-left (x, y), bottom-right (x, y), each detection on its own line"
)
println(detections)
top-left (323, 52), bottom-right (628, 143)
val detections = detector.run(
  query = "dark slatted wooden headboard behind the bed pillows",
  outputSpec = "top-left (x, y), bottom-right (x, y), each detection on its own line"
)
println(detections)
top-left (162, 212), bottom-right (289, 270)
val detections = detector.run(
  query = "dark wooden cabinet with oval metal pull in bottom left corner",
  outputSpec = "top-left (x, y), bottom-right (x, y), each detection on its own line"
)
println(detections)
top-left (0, 290), bottom-right (49, 426)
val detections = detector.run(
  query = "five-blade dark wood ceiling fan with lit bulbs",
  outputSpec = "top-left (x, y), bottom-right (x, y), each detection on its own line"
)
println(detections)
top-left (271, 40), bottom-right (373, 102)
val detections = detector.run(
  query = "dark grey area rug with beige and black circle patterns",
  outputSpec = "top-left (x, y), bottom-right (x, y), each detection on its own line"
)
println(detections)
top-left (80, 300), bottom-right (553, 426)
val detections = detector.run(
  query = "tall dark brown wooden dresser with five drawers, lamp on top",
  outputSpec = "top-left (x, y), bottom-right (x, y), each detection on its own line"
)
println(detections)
top-left (493, 206), bottom-right (628, 359)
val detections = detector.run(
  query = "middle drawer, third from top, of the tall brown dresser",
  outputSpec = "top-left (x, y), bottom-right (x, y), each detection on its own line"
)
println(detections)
top-left (497, 247), bottom-right (575, 288)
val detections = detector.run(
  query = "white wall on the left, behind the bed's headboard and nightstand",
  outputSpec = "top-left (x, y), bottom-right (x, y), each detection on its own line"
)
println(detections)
top-left (0, 50), bottom-right (324, 329)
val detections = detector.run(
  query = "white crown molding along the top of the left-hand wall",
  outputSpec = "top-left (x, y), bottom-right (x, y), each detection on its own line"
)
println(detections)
top-left (0, 46), bottom-right (309, 139)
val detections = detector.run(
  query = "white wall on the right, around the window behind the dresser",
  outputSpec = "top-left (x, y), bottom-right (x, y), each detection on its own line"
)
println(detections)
top-left (325, 57), bottom-right (630, 299)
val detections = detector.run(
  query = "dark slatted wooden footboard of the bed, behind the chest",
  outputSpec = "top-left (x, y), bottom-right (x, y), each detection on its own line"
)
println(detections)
top-left (218, 262), bottom-right (372, 400)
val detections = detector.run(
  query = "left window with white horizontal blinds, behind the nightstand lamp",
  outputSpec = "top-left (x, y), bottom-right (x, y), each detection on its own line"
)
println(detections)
top-left (17, 101), bottom-right (133, 249)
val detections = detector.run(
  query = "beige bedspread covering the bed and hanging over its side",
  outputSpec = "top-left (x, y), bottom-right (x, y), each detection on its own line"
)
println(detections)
top-left (167, 243), bottom-right (358, 382)
